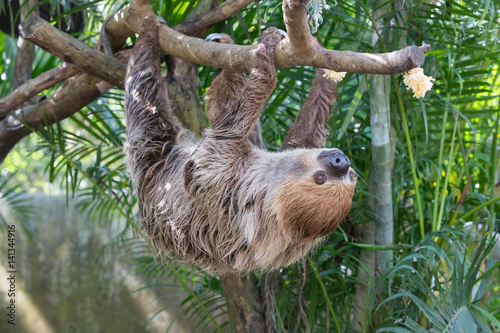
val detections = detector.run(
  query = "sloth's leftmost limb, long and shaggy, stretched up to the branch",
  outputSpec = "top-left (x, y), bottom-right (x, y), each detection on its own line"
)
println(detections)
top-left (125, 16), bottom-right (182, 189)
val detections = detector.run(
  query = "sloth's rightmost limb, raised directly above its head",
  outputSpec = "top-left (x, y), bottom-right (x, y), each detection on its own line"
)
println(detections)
top-left (281, 68), bottom-right (337, 150)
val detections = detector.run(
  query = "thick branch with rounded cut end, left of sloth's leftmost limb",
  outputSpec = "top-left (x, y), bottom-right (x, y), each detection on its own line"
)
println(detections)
top-left (21, 16), bottom-right (127, 89)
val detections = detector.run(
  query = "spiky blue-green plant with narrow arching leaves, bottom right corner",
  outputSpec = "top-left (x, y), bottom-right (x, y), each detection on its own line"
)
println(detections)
top-left (377, 228), bottom-right (500, 332)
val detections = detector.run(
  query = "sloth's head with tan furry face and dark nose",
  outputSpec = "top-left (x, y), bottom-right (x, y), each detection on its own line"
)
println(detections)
top-left (273, 149), bottom-right (357, 242)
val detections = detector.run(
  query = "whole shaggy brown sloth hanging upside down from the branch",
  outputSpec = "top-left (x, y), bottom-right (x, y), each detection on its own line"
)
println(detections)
top-left (125, 17), bottom-right (356, 274)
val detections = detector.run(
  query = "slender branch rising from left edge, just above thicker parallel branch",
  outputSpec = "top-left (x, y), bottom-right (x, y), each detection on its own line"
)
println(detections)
top-left (0, 63), bottom-right (80, 120)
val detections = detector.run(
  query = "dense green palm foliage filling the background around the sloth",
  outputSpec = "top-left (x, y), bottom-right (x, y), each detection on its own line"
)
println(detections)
top-left (0, 0), bottom-right (500, 332)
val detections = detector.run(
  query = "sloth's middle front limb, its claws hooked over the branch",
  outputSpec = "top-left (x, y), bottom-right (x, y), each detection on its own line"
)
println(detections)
top-left (212, 28), bottom-right (281, 142)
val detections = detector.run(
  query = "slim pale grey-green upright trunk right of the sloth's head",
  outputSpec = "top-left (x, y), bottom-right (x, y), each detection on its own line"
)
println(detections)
top-left (352, 0), bottom-right (394, 332)
